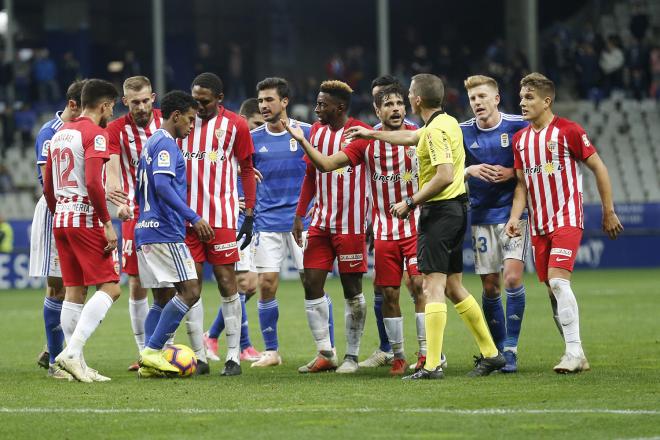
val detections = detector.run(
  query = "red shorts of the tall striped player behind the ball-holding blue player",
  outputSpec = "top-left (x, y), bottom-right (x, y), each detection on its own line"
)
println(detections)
top-left (186, 228), bottom-right (240, 266)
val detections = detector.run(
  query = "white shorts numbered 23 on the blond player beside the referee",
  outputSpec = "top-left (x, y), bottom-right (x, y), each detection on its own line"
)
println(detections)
top-left (472, 220), bottom-right (529, 275)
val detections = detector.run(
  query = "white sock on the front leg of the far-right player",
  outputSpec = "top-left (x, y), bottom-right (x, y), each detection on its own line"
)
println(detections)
top-left (549, 278), bottom-right (584, 357)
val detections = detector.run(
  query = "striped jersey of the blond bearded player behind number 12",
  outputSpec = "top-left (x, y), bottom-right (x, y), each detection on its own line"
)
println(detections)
top-left (106, 109), bottom-right (163, 218)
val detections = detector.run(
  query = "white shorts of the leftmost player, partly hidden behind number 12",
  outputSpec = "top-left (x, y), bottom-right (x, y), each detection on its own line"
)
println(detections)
top-left (29, 195), bottom-right (62, 278)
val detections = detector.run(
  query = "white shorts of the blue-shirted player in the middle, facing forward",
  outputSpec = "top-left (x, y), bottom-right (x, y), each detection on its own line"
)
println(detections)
top-left (254, 231), bottom-right (307, 273)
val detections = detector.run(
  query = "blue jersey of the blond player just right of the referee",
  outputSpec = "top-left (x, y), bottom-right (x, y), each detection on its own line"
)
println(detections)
top-left (460, 113), bottom-right (528, 225)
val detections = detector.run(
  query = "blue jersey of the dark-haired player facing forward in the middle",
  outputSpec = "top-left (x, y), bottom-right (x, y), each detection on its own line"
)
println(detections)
top-left (250, 119), bottom-right (312, 232)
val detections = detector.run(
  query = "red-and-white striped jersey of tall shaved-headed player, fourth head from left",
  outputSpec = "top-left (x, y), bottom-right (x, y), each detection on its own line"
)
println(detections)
top-left (178, 106), bottom-right (254, 229)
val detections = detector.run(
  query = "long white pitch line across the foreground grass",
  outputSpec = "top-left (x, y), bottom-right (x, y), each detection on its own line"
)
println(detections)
top-left (0, 407), bottom-right (660, 416)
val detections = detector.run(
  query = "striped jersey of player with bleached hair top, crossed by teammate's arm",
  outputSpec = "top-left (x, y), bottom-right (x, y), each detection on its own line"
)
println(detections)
top-left (305, 118), bottom-right (369, 234)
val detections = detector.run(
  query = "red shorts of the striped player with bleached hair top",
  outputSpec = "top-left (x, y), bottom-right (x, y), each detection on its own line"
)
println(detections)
top-left (303, 227), bottom-right (367, 273)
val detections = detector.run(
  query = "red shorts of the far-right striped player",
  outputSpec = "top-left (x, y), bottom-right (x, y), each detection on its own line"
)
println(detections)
top-left (532, 226), bottom-right (582, 282)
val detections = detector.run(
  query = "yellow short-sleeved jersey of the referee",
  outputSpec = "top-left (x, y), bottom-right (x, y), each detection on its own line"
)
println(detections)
top-left (417, 113), bottom-right (465, 202)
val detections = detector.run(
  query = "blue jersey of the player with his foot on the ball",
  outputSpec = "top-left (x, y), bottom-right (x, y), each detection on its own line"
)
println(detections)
top-left (135, 129), bottom-right (187, 247)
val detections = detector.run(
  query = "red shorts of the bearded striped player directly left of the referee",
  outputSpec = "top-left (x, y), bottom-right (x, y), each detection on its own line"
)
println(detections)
top-left (374, 236), bottom-right (419, 286)
